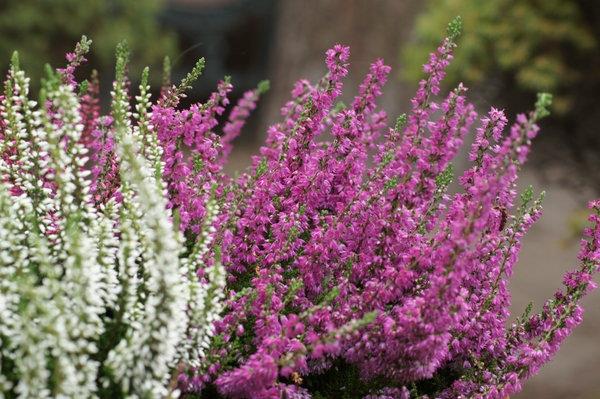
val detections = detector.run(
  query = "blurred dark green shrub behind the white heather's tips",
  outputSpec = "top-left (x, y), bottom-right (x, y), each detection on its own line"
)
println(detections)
top-left (0, 0), bottom-right (175, 83)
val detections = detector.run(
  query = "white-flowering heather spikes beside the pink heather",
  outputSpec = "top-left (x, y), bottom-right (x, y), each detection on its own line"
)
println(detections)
top-left (0, 41), bottom-right (225, 399)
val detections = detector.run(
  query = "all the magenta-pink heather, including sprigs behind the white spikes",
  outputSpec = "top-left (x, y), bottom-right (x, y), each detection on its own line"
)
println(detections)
top-left (41, 19), bottom-right (600, 399)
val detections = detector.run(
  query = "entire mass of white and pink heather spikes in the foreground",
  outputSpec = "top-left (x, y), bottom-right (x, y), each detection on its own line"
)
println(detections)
top-left (0, 20), bottom-right (600, 399)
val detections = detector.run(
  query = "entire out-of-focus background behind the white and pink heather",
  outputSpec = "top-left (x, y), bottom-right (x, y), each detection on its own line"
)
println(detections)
top-left (0, 0), bottom-right (600, 399)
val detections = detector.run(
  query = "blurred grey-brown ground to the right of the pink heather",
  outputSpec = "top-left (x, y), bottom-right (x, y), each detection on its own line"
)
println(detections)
top-left (511, 170), bottom-right (600, 399)
